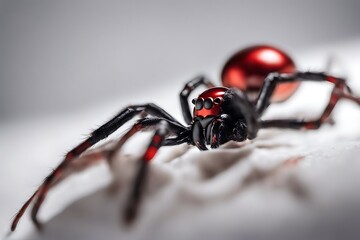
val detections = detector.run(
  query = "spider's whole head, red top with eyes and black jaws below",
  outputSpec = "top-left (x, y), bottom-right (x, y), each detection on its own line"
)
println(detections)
top-left (192, 87), bottom-right (247, 150)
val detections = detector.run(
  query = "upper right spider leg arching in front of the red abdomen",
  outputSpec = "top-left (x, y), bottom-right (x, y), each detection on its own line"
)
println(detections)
top-left (256, 72), bottom-right (351, 116)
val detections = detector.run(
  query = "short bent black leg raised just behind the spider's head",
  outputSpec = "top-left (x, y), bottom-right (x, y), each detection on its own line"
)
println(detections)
top-left (180, 76), bottom-right (214, 124)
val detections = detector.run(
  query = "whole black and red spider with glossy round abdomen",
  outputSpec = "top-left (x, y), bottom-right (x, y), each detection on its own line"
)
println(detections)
top-left (11, 45), bottom-right (360, 231)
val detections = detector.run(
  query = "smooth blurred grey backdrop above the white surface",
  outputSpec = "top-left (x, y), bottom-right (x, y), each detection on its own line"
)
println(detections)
top-left (0, 0), bottom-right (360, 122)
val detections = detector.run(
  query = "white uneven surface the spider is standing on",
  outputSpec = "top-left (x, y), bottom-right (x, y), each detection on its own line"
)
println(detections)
top-left (0, 40), bottom-right (360, 239)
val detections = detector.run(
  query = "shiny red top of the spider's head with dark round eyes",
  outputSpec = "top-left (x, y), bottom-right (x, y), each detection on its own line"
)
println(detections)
top-left (193, 87), bottom-right (228, 118)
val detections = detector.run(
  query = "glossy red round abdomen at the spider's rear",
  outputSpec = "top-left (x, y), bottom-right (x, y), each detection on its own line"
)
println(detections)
top-left (221, 45), bottom-right (299, 102)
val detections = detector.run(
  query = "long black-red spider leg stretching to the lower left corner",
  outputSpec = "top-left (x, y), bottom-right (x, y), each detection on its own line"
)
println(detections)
top-left (11, 103), bottom-right (183, 231)
